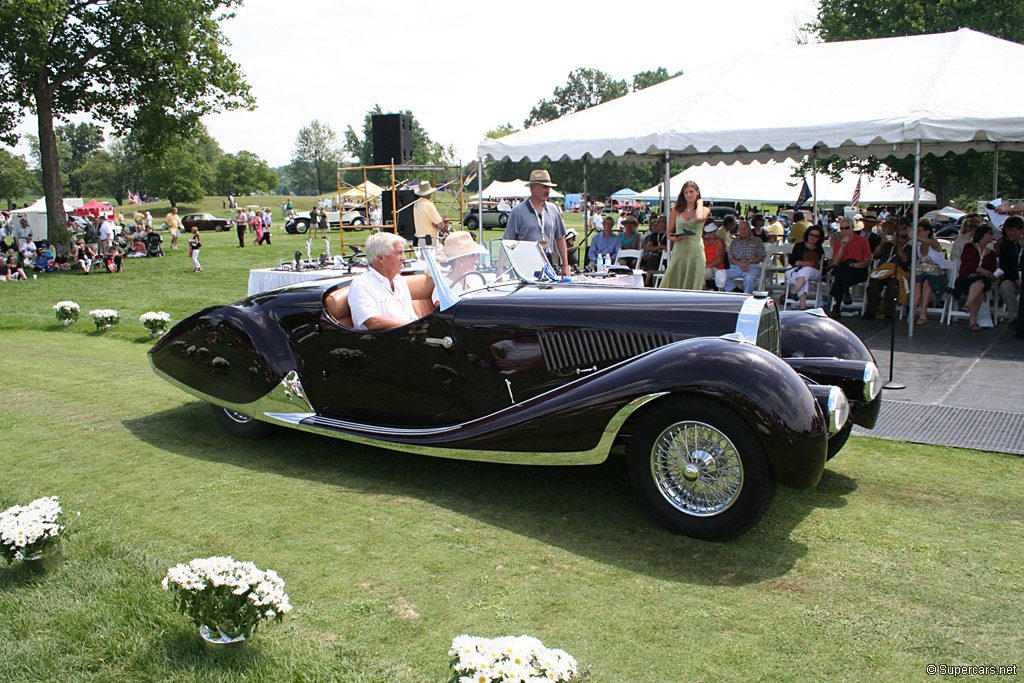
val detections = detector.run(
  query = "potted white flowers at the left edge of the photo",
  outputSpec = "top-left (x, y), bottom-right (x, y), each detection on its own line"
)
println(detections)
top-left (0, 496), bottom-right (65, 571)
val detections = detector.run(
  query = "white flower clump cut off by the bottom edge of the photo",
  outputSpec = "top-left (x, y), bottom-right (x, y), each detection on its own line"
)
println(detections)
top-left (449, 635), bottom-right (577, 683)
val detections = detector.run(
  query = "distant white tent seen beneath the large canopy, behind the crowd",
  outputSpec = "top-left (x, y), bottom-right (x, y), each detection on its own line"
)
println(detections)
top-left (633, 161), bottom-right (935, 206)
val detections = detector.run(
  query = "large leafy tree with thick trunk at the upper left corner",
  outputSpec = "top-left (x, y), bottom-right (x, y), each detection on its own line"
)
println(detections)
top-left (0, 0), bottom-right (255, 242)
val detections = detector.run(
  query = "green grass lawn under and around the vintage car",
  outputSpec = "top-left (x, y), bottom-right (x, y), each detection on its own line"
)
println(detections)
top-left (0, 227), bottom-right (1024, 682)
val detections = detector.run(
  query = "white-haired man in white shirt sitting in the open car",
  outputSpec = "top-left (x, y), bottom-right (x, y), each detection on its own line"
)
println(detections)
top-left (348, 232), bottom-right (416, 331)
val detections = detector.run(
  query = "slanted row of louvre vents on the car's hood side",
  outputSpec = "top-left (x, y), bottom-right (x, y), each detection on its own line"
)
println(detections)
top-left (538, 329), bottom-right (679, 374)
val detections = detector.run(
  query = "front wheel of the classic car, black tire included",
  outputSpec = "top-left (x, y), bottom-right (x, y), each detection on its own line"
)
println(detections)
top-left (627, 396), bottom-right (775, 541)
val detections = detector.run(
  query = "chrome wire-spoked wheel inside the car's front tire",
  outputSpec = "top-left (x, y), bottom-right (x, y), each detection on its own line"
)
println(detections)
top-left (650, 422), bottom-right (743, 517)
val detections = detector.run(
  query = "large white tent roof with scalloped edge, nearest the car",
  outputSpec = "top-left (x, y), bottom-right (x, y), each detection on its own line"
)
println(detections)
top-left (477, 29), bottom-right (1024, 163)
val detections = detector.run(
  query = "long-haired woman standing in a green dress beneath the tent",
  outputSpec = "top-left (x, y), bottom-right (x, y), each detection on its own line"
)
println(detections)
top-left (662, 180), bottom-right (711, 290)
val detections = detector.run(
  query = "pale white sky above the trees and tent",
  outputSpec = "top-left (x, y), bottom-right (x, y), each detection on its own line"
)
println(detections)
top-left (6, 0), bottom-right (815, 166)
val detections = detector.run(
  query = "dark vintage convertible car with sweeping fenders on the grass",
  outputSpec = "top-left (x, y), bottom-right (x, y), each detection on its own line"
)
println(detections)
top-left (150, 242), bottom-right (881, 540)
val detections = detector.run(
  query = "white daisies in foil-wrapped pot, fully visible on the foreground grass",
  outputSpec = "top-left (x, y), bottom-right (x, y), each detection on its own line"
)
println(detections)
top-left (162, 557), bottom-right (292, 652)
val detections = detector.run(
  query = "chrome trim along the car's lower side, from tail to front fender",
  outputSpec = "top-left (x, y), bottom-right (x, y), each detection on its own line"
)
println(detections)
top-left (150, 356), bottom-right (669, 465)
